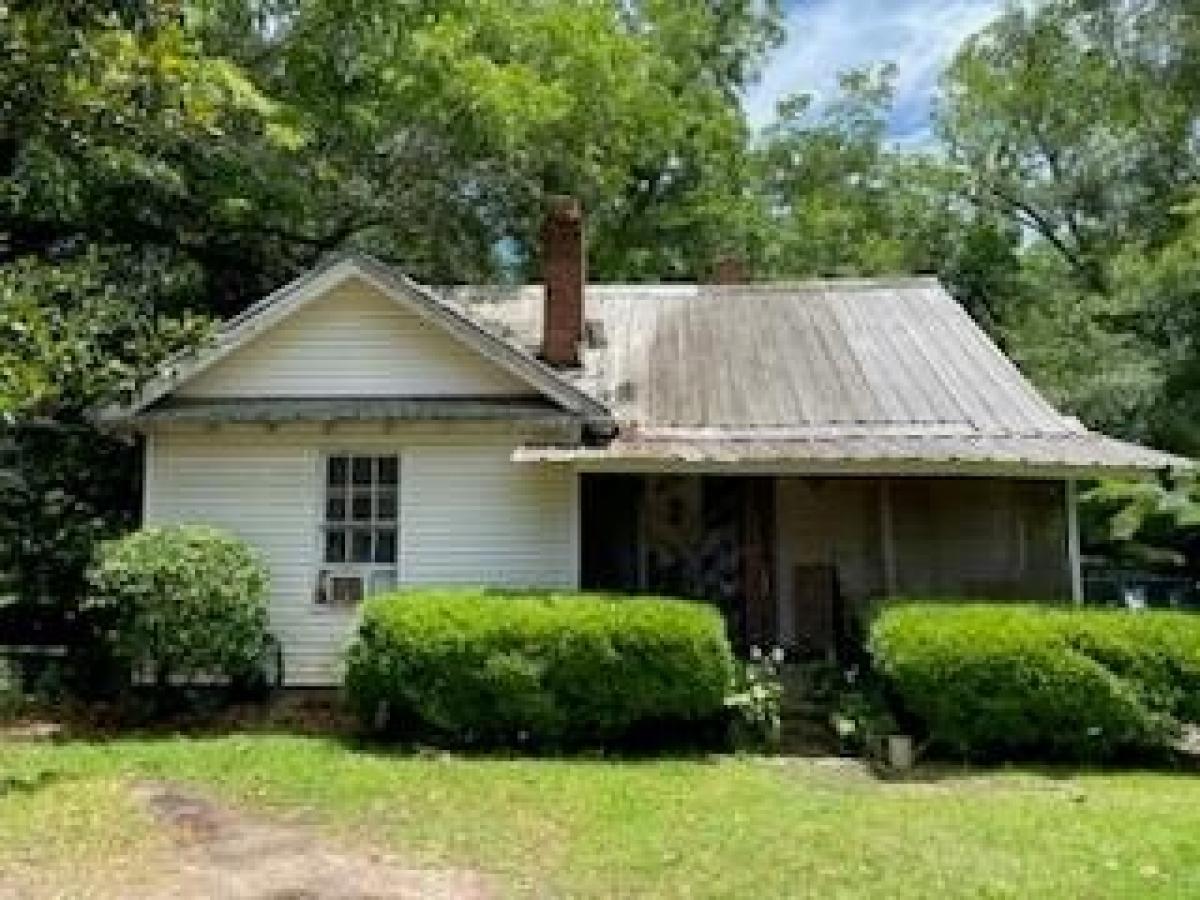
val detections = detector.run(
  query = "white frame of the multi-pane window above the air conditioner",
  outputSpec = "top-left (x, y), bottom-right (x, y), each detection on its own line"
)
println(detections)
top-left (313, 449), bottom-right (403, 610)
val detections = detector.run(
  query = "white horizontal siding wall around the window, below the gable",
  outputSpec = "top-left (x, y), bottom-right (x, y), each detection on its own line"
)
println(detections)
top-left (145, 425), bottom-right (578, 685)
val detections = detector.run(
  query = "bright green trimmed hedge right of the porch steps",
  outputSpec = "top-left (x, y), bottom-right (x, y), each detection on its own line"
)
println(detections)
top-left (870, 604), bottom-right (1200, 760)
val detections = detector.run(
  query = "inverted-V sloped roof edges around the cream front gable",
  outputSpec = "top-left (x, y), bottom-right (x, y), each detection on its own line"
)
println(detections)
top-left (100, 253), bottom-right (611, 426)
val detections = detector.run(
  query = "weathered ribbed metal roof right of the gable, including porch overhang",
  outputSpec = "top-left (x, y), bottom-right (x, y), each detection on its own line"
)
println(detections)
top-left (445, 277), bottom-right (1187, 470)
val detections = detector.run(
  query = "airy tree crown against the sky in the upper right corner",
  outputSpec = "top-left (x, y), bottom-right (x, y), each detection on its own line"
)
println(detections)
top-left (940, 0), bottom-right (1200, 293)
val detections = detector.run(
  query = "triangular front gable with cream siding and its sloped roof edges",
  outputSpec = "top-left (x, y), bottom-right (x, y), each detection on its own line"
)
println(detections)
top-left (103, 256), bottom-right (607, 421)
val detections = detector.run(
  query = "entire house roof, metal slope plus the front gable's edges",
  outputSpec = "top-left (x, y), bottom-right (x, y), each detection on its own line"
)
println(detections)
top-left (102, 254), bottom-right (1190, 474)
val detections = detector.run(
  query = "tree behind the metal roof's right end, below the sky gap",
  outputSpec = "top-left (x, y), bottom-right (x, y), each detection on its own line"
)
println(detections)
top-left (758, 65), bottom-right (1020, 331)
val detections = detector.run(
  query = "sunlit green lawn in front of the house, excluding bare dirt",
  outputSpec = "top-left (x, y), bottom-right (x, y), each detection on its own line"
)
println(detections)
top-left (0, 736), bottom-right (1200, 898)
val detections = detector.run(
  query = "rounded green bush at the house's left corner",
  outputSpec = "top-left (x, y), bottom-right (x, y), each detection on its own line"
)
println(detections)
top-left (89, 526), bottom-right (268, 686)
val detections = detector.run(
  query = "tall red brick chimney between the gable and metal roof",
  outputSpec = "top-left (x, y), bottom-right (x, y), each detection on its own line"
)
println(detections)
top-left (541, 197), bottom-right (587, 366)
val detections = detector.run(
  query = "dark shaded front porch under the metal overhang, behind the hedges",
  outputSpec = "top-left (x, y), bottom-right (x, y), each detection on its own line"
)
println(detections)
top-left (580, 474), bottom-right (1075, 656)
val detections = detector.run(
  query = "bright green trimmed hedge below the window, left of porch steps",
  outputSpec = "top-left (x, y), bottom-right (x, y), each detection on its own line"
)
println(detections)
top-left (346, 590), bottom-right (733, 746)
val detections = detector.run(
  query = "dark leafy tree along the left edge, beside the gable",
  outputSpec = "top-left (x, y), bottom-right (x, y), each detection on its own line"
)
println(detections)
top-left (0, 0), bottom-right (288, 612)
